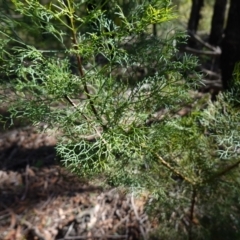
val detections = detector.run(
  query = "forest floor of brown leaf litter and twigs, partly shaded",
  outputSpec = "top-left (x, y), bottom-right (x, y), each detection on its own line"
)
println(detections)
top-left (0, 126), bottom-right (154, 240)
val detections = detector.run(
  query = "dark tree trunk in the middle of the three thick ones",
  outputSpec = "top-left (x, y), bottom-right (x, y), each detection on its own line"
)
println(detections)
top-left (209, 0), bottom-right (227, 46)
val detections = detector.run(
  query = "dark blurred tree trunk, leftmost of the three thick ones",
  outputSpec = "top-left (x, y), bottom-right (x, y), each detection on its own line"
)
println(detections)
top-left (188, 0), bottom-right (204, 47)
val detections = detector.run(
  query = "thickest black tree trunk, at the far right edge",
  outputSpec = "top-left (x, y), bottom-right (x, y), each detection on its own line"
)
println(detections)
top-left (221, 0), bottom-right (240, 89)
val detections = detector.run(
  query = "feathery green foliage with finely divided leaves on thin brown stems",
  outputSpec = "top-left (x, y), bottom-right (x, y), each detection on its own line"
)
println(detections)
top-left (0, 0), bottom-right (240, 239)
